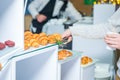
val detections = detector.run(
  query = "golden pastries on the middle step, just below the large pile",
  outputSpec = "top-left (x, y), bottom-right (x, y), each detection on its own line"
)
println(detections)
top-left (58, 49), bottom-right (72, 60)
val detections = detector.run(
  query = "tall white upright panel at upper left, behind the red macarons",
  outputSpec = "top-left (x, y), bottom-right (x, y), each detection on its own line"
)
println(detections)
top-left (0, 0), bottom-right (24, 47)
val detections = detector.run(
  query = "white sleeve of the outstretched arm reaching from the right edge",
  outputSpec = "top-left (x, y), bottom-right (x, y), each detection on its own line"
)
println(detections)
top-left (70, 8), bottom-right (120, 38)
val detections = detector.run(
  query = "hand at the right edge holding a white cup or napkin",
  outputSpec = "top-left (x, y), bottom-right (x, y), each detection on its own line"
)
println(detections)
top-left (104, 33), bottom-right (120, 49)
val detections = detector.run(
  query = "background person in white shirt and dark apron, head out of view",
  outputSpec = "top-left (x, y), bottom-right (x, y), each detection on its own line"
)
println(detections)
top-left (28, 0), bottom-right (82, 33)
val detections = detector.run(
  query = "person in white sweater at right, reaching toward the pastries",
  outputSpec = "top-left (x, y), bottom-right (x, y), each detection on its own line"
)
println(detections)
top-left (62, 8), bottom-right (120, 79)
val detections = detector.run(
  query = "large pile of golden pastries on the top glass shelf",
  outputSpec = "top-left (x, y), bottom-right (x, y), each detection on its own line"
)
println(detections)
top-left (24, 31), bottom-right (62, 50)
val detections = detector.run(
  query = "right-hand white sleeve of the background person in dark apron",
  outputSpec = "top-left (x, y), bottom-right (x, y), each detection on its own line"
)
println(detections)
top-left (66, 1), bottom-right (82, 20)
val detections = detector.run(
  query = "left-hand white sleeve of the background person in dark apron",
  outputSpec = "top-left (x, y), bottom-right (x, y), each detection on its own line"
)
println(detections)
top-left (28, 0), bottom-right (41, 19)
